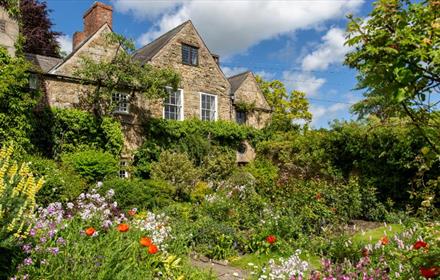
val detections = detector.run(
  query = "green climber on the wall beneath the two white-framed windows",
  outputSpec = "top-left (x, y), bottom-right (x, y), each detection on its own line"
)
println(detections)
top-left (134, 119), bottom-right (262, 178)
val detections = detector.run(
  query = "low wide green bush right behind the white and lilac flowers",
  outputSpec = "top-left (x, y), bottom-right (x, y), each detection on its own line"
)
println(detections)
top-left (99, 178), bottom-right (175, 209)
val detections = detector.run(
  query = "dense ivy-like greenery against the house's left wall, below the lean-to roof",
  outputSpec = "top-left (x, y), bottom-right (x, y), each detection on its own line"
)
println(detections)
top-left (33, 108), bottom-right (124, 158)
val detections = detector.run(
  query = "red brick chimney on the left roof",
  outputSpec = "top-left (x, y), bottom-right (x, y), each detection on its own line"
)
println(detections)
top-left (73, 2), bottom-right (113, 50)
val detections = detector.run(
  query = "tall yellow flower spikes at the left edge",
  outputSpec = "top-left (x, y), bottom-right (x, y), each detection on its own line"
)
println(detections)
top-left (0, 147), bottom-right (43, 241)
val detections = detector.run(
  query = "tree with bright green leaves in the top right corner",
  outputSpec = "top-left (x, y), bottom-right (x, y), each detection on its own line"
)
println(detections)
top-left (345, 0), bottom-right (440, 151)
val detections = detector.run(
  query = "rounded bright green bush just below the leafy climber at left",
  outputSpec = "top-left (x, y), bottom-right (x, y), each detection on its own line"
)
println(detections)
top-left (61, 149), bottom-right (119, 183)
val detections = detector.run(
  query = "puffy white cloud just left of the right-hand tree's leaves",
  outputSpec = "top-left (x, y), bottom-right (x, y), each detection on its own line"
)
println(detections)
top-left (302, 28), bottom-right (351, 71)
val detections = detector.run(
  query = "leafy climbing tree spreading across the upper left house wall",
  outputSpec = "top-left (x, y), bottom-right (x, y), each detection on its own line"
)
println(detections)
top-left (75, 33), bottom-right (180, 116)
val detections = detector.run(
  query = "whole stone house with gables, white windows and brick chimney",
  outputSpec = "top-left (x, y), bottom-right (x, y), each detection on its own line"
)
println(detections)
top-left (1, 2), bottom-right (271, 168)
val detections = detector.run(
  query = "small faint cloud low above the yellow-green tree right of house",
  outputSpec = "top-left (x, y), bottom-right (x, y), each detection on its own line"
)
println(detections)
top-left (282, 71), bottom-right (326, 97)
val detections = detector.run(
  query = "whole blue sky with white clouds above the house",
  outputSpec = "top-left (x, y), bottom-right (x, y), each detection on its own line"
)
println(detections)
top-left (47, 0), bottom-right (373, 128)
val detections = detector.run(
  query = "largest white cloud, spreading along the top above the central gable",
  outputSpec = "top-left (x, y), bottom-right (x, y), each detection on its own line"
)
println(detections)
top-left (113, 0), bottom-right (363, 55)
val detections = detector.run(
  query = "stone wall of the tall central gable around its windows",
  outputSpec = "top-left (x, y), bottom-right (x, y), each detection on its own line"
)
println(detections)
top-left (150, 22), bottom-right (233, 120)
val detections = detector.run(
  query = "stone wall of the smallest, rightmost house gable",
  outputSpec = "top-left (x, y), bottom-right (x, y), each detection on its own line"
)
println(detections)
top-left (234, 73), bottom-right (271, 129)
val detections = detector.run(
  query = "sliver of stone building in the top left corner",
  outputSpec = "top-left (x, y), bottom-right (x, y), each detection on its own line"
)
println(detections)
top-left (0, 7), bottom-right (19, 56)
